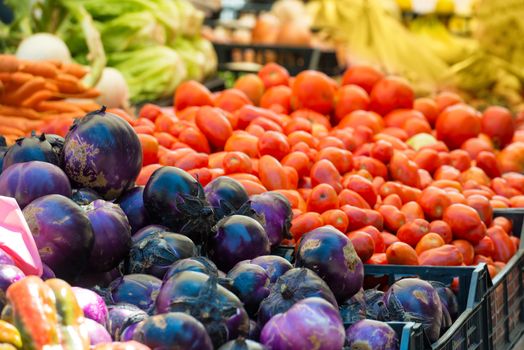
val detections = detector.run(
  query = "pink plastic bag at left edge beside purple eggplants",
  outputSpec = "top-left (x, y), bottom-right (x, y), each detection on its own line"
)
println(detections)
top-left (0, 196), bottom-right (42, 276)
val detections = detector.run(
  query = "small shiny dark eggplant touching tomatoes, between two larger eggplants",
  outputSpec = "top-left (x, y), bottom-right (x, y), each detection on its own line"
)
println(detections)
top-left (204, 176), bottom-right (249, 221)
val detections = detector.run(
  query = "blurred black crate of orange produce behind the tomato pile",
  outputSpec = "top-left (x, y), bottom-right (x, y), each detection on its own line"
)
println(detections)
top-left (213, 43), bottom-right (343, 76)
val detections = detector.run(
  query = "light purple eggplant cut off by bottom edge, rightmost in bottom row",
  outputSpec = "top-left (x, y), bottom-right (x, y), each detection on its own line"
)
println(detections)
top-left (346, 320), bottom-right (399, 350)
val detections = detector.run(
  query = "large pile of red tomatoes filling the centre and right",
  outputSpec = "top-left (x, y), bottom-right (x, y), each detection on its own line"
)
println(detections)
top-left (48, 64), bottom-right (524, 276)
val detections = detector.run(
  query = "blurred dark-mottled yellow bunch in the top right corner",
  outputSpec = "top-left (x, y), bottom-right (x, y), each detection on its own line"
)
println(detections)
top-left (473, 0), bottom-right (524, 67)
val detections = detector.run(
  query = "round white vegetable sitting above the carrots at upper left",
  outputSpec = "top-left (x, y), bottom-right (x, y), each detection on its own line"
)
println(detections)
top-left (16, 33), bottom-right (71, 63)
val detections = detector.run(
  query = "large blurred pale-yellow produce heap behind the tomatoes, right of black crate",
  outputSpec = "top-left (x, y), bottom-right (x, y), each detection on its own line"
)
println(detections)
top-left (309, 0), bottom-right (448, 91)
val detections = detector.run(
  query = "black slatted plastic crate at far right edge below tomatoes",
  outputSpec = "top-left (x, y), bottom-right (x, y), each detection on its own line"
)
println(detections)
top-left (485, 208), bottom-right (524, 350)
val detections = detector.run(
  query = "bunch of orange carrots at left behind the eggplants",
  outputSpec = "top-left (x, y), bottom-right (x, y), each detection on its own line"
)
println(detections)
top-left (0, 55), bottom-right (100, 143)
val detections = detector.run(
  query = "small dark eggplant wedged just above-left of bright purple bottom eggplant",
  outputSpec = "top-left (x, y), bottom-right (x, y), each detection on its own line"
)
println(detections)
top-left (227, 262), bottom-right (269, 316)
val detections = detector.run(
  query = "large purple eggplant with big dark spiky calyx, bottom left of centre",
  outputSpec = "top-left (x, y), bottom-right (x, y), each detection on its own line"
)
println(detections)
top-left (156, 271), bottom-right (249, 347)
